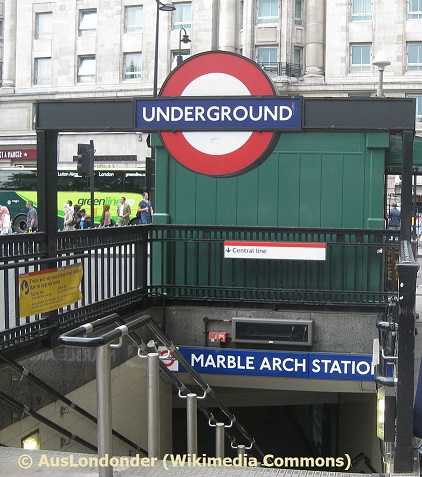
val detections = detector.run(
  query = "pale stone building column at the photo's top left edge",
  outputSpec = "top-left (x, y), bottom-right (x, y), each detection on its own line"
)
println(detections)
top-left (2, 0), bottom-right (17, 88)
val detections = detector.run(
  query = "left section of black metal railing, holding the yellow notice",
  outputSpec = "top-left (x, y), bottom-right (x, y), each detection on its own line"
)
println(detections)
top-left (0, 226), bottom-right (148, 349)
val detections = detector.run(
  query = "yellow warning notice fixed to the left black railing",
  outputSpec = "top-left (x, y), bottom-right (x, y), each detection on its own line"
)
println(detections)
top-left (19, 263), bottom-right (83, 318)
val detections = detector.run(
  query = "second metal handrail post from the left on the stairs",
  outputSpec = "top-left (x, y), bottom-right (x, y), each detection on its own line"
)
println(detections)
top-left (148, 353), bottom-right (160, 458)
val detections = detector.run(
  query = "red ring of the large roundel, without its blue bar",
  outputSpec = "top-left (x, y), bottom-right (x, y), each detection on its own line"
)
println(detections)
top-left (159, 51), bottom-right (278, 176)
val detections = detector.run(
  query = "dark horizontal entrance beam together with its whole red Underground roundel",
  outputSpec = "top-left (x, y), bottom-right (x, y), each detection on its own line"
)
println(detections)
top-left (37, 51), bottom-right (415, 177)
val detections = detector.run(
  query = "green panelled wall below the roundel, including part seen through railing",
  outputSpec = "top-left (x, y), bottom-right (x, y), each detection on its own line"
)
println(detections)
top-left (153, 133), bottom-right (389, 291)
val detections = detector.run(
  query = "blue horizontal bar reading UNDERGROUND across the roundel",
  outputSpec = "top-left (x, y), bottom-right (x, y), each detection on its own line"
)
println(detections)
top-left (135, 96), bottom-right (302, 131)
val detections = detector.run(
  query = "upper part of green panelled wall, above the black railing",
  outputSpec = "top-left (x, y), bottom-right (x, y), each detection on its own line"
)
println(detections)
top-left (155, 129), bottom-right (389, 228)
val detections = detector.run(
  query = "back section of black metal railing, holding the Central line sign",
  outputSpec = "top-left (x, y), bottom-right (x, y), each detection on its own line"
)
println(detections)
top-left (149, 226), bottom-right (399, 307)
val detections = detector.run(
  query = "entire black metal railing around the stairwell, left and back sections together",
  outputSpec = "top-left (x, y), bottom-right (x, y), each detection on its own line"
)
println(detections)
top-left (0, 225), bottom-right (399, 350)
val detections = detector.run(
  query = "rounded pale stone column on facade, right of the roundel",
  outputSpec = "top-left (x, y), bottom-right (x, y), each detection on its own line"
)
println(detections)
top-left (305, 0), bottom-right (325, 76)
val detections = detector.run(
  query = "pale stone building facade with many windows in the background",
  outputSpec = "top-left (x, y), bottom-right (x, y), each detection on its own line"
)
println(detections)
top-left (0, 0), bottom-right (422, 168)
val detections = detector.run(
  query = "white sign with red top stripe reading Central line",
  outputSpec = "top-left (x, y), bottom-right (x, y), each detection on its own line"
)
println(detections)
top-left (224, 240), bottom-right (327, 260)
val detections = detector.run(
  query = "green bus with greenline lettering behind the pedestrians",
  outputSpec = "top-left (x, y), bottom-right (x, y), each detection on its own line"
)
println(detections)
top-left (0, 167), bottom-right (145, 232)
